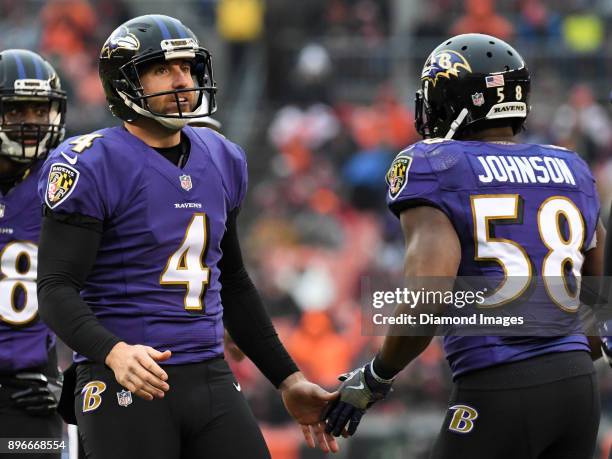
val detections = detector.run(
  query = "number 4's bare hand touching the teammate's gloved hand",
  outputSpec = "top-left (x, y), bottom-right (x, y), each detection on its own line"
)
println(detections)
top-left (280, 372), bottom-right (340, 453)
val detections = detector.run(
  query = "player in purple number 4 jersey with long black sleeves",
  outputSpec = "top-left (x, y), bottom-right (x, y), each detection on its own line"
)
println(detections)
top-left (38, 15), bottom-right (338, 459)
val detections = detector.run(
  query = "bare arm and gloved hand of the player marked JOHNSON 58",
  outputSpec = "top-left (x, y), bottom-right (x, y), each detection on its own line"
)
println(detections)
top-left (323, 206), bottom-right (461, 436)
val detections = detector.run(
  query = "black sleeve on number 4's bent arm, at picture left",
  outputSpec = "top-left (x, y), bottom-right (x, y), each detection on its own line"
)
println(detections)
top-left (37, 209), bottom-right (121, 363)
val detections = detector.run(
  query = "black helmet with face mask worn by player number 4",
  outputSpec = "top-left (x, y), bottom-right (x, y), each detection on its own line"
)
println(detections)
top-left (99, 14), bottom-right (217, 129)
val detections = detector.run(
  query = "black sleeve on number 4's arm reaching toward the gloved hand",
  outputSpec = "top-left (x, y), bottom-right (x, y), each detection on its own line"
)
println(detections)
top-left (219, 209), bottom-right (298, 387)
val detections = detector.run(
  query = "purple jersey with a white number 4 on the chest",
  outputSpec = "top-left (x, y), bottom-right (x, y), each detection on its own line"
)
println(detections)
top-left (39, 127), bottom-right (247, 364)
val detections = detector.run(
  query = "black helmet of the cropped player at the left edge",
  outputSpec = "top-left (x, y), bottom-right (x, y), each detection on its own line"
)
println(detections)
top-left (0, 49), bottom-right (66, 165)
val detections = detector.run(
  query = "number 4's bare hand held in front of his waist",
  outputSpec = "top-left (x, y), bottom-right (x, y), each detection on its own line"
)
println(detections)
top-left (104, 342), bottom-right (171, 400)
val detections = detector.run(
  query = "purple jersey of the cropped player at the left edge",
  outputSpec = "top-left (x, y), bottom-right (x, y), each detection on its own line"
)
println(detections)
top-left (0, 162), bottom-right (55, 374)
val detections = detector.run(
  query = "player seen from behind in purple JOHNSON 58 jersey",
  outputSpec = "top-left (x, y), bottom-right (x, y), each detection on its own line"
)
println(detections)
top-left (326, 34), bottom-right (605, 459)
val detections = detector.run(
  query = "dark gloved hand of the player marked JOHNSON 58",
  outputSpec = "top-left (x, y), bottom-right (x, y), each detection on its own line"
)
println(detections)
top-left (323, 363), bottom-right (393, 437)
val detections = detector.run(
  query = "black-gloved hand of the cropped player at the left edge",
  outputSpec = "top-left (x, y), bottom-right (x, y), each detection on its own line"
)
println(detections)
top-left (11, 373), bottom-right (62, 416)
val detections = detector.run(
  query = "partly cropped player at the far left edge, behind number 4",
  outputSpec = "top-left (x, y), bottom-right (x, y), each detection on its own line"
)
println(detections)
top-left (0, 49), bottom-right (66, 458)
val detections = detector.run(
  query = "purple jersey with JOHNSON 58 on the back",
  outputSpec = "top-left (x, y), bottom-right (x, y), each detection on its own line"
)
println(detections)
top-left (387, 139), bottom-right (599, 377)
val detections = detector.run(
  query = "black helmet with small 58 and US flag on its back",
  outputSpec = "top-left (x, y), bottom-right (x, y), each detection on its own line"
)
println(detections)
top-left (415, 33), bottom-right (530, 139)
